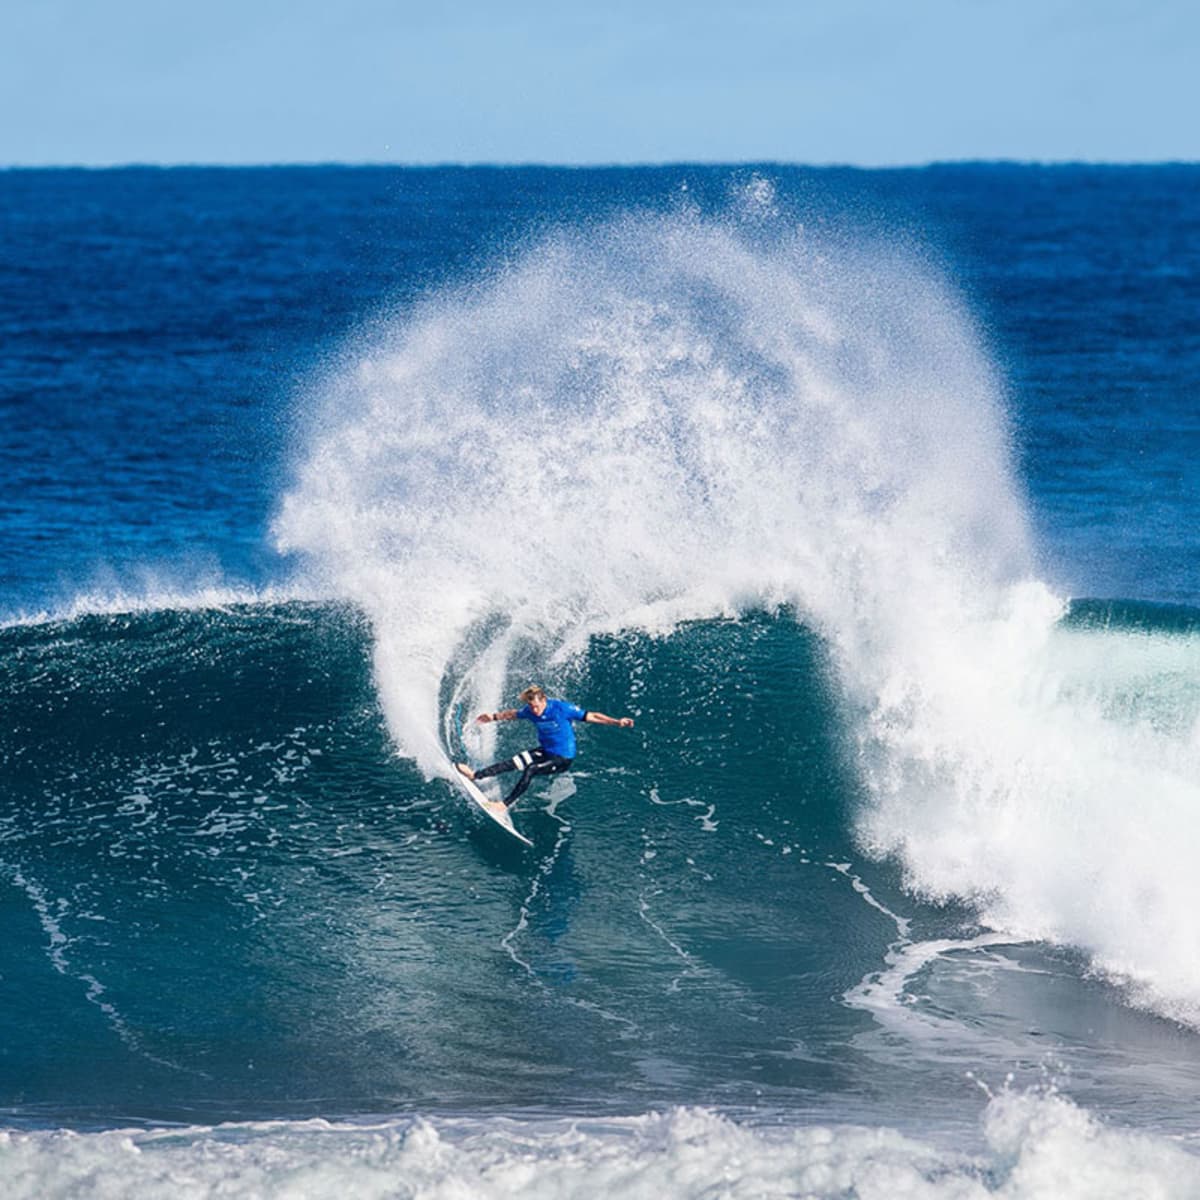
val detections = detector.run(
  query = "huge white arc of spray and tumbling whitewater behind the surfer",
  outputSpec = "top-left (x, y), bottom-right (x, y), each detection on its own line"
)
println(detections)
top-left (276, 204), bottom-right (1200, 1021)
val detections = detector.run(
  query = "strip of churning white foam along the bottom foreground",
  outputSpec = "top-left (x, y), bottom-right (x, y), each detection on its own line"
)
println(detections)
top-left (0, 1093), bottom-right (1200, 1200)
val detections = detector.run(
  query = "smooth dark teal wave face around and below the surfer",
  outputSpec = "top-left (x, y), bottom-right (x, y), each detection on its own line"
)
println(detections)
top-left (7, 602), bottom-right (1200, 1132)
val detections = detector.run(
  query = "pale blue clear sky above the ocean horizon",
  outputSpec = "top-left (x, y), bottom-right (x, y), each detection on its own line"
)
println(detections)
top-left (0, 0), bottom-right (1200, 164)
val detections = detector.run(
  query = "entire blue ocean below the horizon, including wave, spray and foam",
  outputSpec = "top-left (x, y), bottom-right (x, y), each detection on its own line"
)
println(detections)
top-left (0, 164), bottom-right (1200, 1200)
